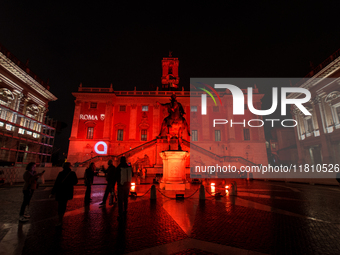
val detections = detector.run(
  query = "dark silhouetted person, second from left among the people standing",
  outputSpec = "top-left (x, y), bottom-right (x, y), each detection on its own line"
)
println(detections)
top-left (50, 162), bottom-right (78, 226)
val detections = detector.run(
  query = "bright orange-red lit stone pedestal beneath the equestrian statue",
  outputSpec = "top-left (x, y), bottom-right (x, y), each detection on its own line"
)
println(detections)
top-left (159, 151), bottom-right (190, 190)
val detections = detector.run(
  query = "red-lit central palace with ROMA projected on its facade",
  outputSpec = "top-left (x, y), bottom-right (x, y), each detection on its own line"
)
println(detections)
top-left (68, 57), bottom-right (267, 173)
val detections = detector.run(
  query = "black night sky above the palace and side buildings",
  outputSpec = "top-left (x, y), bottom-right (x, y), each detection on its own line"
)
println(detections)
top-left (0, 1), bottom-right (340, 156)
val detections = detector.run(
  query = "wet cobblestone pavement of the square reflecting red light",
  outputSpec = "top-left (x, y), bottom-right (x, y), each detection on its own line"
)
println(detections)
top-left (0, 178), bottom-right (340, 255)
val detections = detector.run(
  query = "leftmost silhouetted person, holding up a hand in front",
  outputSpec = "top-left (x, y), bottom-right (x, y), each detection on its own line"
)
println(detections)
top-left (19, 162), bottom-right (45, 222)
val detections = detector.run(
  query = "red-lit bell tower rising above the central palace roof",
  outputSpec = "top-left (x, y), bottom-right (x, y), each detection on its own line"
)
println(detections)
top-left (162, 51), bottom-right (180, 90)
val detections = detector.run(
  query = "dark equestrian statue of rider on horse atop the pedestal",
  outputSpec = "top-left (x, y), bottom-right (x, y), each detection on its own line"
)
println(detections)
top-left (157, 94), bottom-right (190, 150)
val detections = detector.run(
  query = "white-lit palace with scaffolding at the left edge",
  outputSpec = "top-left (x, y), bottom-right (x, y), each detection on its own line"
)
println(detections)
top-left (0, 45), bottom-right (57, 165)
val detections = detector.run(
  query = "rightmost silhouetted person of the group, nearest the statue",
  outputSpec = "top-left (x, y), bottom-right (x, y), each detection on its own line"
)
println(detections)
top-left (117, 156), bottom-right (132, 220)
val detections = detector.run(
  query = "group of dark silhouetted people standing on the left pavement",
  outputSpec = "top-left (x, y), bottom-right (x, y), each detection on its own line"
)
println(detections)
top-left (19, 156), bottom-right (132, 226)
